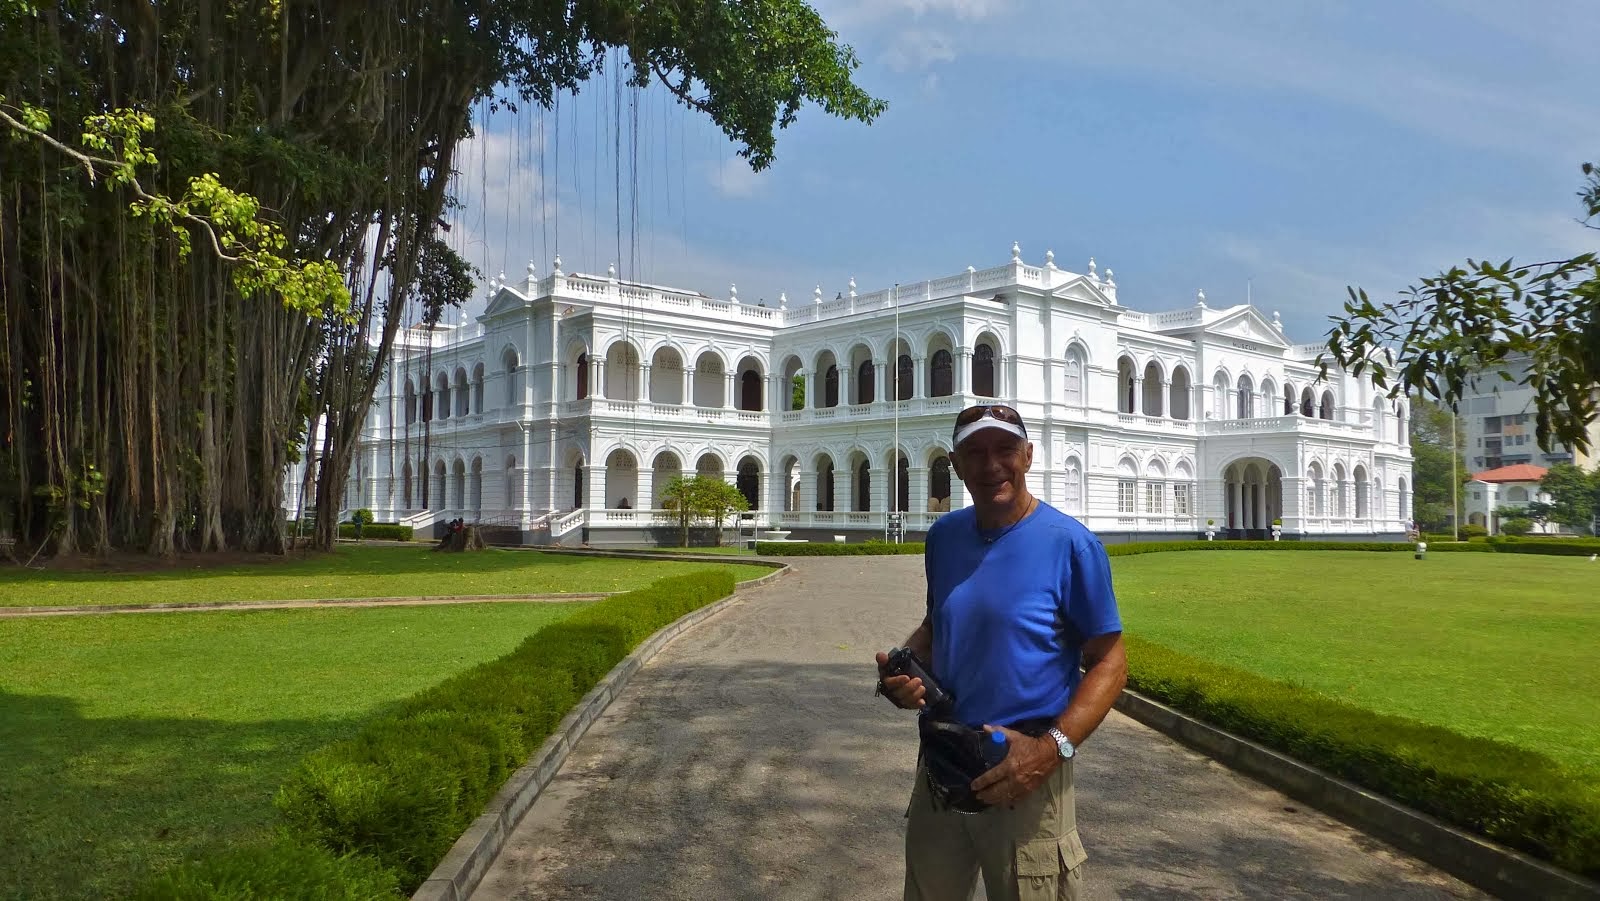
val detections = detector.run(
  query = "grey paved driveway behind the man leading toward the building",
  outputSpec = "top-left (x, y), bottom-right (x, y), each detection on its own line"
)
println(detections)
top-left (474, 557), bottom-right (1483, 901)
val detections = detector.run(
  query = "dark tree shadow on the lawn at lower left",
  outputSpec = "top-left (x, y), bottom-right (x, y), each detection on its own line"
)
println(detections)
top-left (0, 691), bottom-right (370, 901)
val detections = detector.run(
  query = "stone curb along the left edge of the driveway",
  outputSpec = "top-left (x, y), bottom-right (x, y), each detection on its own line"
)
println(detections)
top-left (411, 565), bottom-right (790, 901)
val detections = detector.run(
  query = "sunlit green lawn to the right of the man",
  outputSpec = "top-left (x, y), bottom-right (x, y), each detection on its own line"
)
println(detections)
top-left (1112, 551), bottom-right (1600, 778)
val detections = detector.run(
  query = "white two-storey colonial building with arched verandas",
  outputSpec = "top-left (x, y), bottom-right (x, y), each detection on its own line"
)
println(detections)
top-left (321, 246), bottom-right (1411, 544)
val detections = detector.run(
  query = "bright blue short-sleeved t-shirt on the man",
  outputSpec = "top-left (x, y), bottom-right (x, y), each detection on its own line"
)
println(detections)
top-left (925, 501), bottom-right (1122, 727)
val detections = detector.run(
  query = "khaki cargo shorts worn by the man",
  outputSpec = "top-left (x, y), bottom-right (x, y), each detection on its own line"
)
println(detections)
top-left (906, 760), bottom-right (1086, 901)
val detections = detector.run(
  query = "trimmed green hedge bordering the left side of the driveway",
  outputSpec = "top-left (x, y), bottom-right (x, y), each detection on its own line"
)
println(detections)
top-left (152, 570), bottom-right (734, 901)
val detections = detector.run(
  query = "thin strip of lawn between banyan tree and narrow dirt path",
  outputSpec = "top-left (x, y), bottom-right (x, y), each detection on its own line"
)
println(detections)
top-left (0, 546), bottom-right (771, 607)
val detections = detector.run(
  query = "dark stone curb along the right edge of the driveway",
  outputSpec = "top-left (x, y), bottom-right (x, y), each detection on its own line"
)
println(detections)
top-left (1115, 690), bottom-right (1600, 901)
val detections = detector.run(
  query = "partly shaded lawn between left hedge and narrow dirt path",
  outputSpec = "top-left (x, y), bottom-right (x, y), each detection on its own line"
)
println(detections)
top-left (0, 603), bottom-right (584, 899)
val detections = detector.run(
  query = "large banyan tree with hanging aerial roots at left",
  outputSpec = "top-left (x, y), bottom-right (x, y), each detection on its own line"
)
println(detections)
top-left (0, 0), bottom-right (885, 554)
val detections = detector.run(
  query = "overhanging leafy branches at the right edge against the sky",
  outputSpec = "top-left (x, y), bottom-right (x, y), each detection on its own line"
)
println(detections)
top-left (1323, 163), bottom-right (1600, 451)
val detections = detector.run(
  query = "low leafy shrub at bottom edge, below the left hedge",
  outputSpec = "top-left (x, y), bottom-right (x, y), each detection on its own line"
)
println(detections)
top-left (134, 837), bottom-right (405, 901)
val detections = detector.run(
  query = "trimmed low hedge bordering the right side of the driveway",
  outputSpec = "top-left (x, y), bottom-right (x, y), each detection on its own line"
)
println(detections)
top-left (1125, 635), bottom-right (1600, 877)
